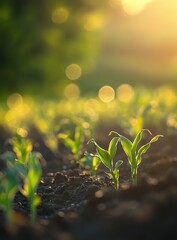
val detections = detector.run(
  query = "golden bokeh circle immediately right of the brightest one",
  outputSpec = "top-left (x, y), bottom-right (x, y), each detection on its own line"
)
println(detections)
top-left (117, 84), bottom-right (135, 102)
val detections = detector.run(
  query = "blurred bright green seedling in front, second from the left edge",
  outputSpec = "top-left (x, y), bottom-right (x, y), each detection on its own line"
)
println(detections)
top-left (20, 153), bottom-right (42, 222)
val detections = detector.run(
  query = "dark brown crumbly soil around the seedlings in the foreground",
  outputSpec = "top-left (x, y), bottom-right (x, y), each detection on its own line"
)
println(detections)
top-left (0, 125), bottom-right (177, 240)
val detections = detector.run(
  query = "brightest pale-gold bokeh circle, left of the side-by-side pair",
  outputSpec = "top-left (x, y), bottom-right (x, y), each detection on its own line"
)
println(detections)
top-left (98, 86), bottom-right (115, 103)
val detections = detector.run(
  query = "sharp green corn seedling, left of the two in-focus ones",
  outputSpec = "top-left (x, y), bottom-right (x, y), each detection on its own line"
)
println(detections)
top-left (89, 137), bottom-right (123, 189)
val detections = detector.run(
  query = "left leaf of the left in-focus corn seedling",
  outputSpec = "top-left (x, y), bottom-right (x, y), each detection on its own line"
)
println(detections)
top-left (90, 139), bottom-right (112, 169)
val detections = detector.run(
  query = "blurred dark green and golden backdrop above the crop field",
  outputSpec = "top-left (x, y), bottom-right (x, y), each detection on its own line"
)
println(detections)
top-left (0, 0), bottom-right (177, 98)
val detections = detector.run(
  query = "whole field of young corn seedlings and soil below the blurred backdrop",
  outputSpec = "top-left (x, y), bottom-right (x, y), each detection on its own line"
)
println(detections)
top-left (0, 84), bottom-right (177, 240)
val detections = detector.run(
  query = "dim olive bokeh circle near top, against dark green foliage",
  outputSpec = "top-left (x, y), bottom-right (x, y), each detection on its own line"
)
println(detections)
top-left (52, 7), bottom-right (69, 24)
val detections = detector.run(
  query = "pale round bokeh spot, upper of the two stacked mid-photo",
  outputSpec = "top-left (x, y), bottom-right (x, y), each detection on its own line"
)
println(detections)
top-left (65, 64), bottom-right (82, 80)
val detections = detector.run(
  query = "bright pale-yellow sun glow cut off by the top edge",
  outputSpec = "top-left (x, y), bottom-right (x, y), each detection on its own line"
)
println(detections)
top-left (122, 0), bottom-right (153, 15)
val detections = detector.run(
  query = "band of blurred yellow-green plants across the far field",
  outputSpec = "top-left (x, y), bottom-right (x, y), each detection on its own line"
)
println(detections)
top-left (0, 84), bottom-right (177, 156)
